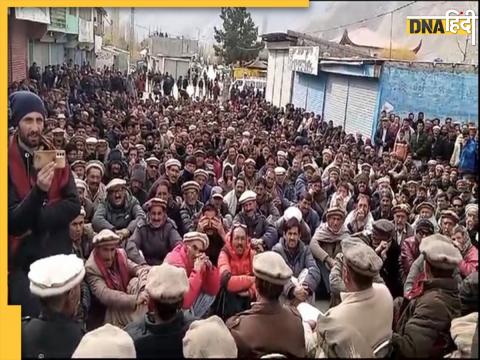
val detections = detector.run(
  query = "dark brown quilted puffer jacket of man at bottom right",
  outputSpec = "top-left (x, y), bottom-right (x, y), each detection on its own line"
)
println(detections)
top-left (392, 279), bottom-right (460, 358)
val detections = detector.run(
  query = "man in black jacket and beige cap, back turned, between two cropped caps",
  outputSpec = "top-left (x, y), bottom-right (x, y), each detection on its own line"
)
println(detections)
top-left (125, 263), bottom-right (195, 359)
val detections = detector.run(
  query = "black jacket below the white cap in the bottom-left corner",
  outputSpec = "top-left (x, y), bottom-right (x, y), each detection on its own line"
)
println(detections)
top-left (22, 313), bottom-right (84, 359)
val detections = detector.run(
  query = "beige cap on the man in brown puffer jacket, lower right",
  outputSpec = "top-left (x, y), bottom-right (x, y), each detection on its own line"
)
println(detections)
top-left (420, 234), bottom-right (463, 270)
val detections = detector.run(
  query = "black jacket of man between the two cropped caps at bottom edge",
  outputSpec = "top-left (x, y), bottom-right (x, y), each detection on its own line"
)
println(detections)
top-left (125, 311), bottom-right (196, 359)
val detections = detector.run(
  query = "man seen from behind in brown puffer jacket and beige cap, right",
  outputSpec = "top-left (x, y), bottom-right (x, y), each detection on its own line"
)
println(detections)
top-left (392, 234), bottom-right (462, 357)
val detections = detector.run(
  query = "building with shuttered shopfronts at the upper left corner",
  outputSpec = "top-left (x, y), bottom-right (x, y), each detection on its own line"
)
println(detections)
top-left (8, 7), bottom-right (106, 83)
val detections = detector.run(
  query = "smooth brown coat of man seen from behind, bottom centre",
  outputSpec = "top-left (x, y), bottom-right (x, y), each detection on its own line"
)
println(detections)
top-left (227, 302), bottom-right (306, 358)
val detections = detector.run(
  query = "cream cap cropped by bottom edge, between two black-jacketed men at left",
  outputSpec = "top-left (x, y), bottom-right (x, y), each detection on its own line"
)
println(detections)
top-left (72, 324), bottom-right (137, 359)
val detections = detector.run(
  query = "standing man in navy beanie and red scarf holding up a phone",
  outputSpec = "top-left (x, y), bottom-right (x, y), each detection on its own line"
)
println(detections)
top-left (8, 91), bottom-right (80, 316)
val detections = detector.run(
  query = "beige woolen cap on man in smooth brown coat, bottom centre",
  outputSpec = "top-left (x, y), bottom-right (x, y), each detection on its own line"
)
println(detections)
top-left (253, 251), bottom-right (293, 285)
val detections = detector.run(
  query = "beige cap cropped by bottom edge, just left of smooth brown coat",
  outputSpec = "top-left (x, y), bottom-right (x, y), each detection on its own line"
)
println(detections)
top-left (183, 315), bottom-right (238, 359)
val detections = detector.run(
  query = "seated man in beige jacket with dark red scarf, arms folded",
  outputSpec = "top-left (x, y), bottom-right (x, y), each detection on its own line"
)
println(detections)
top-left (85, 229), bottom-right (149, 327)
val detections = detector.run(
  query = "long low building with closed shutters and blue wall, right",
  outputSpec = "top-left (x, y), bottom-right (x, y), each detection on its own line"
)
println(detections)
top-left (264, 31), bottom-right (478, 137)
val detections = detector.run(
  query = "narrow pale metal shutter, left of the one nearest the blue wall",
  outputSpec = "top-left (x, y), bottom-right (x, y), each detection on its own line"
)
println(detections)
top-left (324, 75), bottom-right (348, 127)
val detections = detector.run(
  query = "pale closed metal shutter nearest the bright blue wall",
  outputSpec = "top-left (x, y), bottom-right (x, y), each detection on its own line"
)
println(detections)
top-left (345, 77), bottom-right (378, 137)
